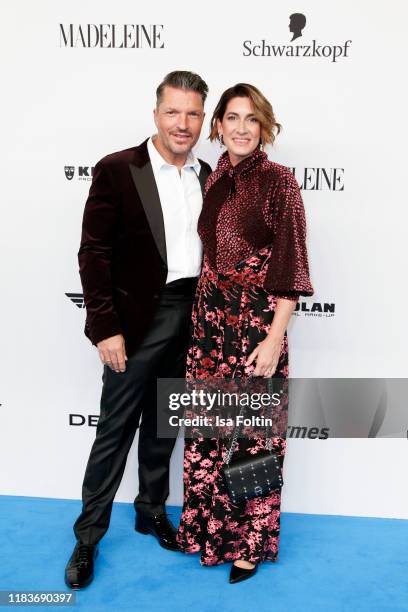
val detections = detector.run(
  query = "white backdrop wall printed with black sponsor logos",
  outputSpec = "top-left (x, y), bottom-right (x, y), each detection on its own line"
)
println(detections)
top-left (0, 0), bottom-right (408, 517)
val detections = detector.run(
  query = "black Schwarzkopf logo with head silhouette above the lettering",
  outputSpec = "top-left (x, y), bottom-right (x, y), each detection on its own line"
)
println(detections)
top-left (242, 13), bottom-right (352, 62)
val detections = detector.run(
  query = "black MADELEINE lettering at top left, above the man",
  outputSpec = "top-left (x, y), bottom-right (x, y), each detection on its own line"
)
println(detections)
top-left (59, 23), bottom-right (164, 49)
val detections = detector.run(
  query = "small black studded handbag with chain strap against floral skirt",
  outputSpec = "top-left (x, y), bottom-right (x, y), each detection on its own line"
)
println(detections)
top-left (221, 380), bottom-right (283, 504)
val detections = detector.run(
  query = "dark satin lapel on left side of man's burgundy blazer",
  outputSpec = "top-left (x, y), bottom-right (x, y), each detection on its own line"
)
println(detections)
top-left (129, 159), bottom-right (167, 266)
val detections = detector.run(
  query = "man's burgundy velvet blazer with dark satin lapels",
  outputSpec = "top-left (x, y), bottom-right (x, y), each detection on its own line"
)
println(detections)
top-left (78, 140), bottom-right (211, 356)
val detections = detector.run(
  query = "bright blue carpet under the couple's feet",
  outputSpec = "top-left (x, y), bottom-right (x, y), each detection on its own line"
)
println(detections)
top-left (0, 496), bottom-right (408, 612)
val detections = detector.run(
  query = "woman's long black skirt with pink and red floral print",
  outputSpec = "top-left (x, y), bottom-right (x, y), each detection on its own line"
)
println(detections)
top-left (177, 248), bottom-right (288, 565)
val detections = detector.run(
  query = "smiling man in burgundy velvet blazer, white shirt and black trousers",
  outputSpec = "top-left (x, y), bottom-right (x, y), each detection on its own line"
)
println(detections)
top-left (65, 71), bottom-right (211, 589)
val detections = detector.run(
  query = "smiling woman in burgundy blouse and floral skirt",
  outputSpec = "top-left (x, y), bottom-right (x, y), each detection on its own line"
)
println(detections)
top-left (177, 83), bottom-right (313, 582)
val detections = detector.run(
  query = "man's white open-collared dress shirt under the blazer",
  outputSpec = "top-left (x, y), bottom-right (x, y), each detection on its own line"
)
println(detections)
top-left (147, 138), bottom-right (203, 283)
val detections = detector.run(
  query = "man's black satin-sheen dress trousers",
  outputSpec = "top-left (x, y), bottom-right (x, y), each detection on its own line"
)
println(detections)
top-left (74, 278), bottom-right (197, 545)
